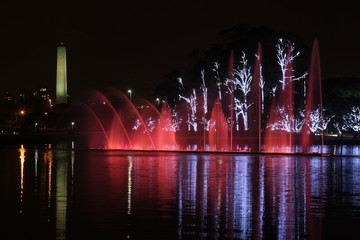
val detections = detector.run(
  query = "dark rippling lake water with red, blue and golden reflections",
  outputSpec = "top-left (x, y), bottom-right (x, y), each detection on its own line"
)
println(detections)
top-left (0, 145), bottom-right (360, 240)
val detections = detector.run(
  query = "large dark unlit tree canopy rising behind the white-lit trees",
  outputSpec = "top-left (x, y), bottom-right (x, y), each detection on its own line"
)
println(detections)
top-left (155, 24), bottom-right (311, 105)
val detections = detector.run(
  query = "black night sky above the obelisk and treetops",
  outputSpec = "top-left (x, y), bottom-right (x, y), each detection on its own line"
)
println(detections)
top-left (0, 0), bottom-right (360, 97)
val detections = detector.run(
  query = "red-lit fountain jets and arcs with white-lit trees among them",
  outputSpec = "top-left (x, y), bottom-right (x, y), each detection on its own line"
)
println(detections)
top-left (63, 39), bottom-right (328, 153)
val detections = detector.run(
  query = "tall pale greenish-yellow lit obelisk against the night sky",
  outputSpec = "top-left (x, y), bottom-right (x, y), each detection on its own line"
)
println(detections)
top-left (56, 44), bottom-right (68, 104)
